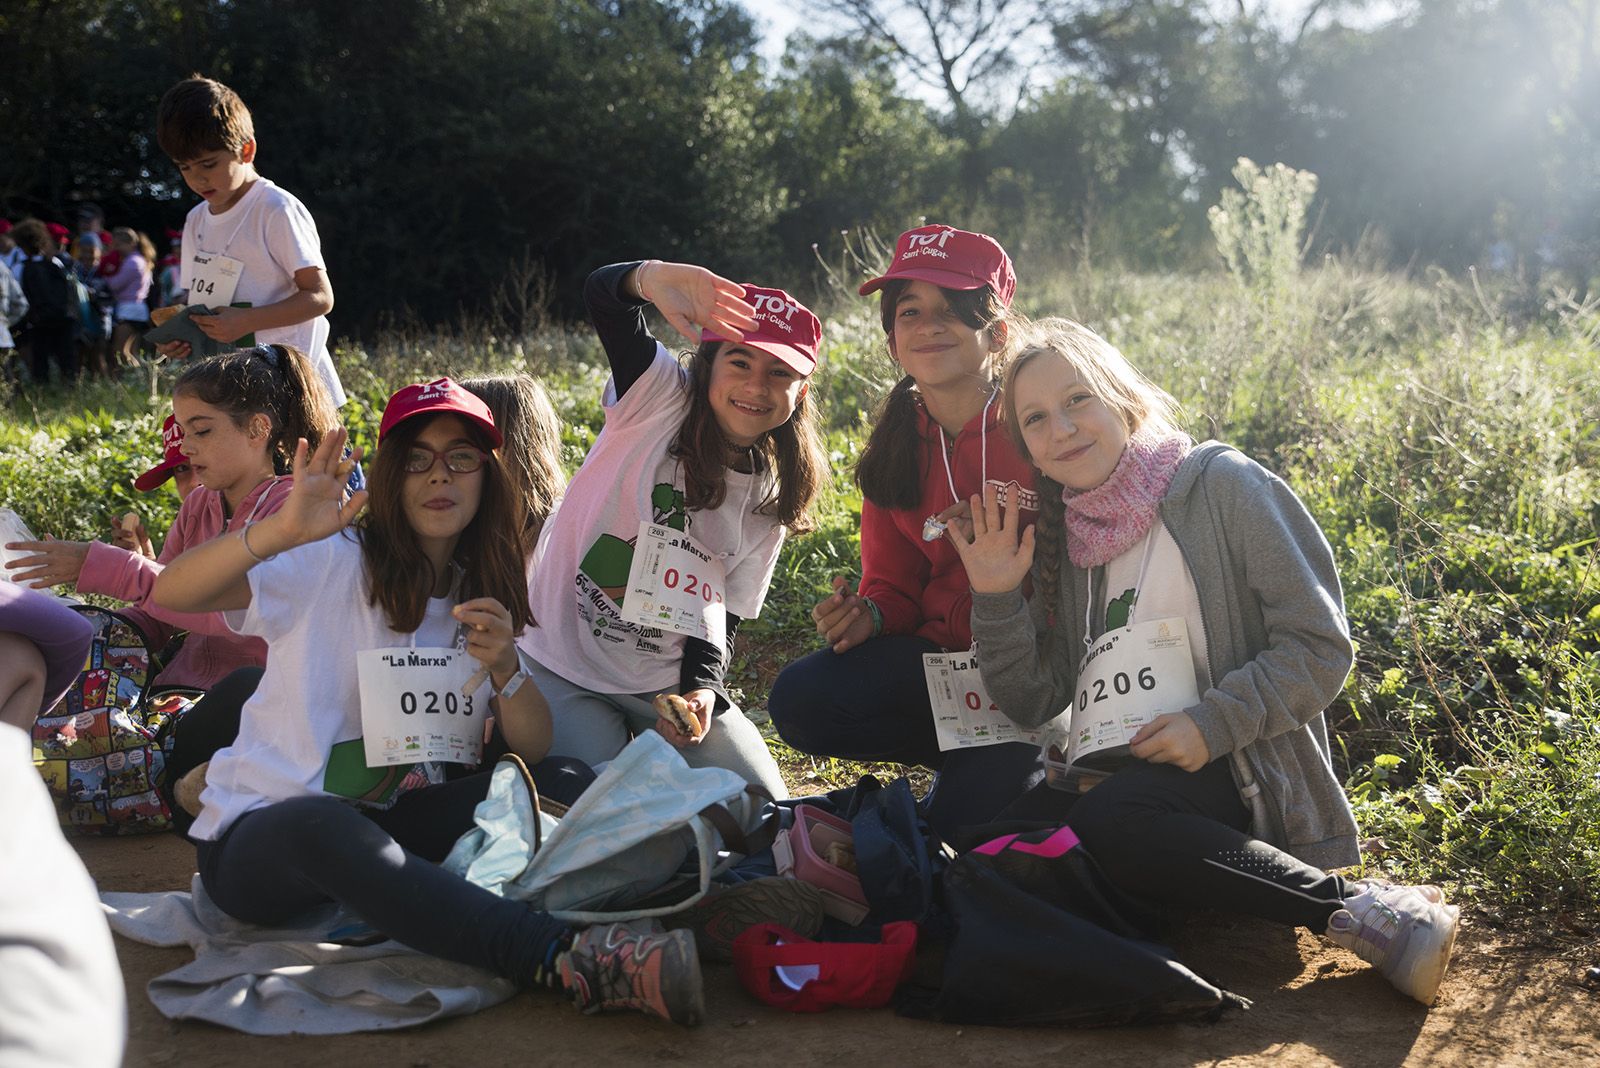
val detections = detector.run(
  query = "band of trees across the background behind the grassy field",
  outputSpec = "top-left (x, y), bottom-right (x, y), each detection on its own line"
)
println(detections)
top-left (0, 0), bottom-right (1600, 331)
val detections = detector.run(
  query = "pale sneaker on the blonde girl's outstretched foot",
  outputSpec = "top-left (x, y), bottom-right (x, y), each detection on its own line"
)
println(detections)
top-left (1328, 879), bottom-right (1461, 1006)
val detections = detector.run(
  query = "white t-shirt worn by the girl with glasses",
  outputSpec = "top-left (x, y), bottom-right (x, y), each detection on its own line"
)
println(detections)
top-left (189, 531), bottom-right (458, 839)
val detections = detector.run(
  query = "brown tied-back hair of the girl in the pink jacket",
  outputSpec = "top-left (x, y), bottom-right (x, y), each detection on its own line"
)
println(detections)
top-left (173, 345), bottom-right (339, 475)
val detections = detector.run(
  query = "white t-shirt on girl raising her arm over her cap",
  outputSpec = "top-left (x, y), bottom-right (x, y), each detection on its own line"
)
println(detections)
top-left (520, 345), bottom-right (784, 694)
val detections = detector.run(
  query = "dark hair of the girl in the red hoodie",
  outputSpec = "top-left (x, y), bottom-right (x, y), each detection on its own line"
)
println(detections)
top-left (856, 278), bottom-right (1016, 508)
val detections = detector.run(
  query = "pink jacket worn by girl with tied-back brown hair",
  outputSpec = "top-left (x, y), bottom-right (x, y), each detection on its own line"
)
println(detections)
top-left (78, 478), bottom-right (290, 689)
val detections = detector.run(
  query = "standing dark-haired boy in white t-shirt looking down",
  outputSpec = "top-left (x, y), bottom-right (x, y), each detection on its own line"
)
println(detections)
top-left (155, 77), bottom-right (344, 404)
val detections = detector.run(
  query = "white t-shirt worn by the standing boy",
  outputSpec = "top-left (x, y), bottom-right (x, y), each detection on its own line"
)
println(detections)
top-left (178, 177), bottom-right (344, 406)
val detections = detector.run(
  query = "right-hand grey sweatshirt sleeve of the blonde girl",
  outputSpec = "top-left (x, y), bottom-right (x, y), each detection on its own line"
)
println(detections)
top-left (1187, 452), bottom-right (1355, 759)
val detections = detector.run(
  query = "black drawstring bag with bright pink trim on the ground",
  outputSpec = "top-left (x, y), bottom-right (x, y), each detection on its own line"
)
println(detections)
top-left (898, 827), bottom-right (1250, 1026)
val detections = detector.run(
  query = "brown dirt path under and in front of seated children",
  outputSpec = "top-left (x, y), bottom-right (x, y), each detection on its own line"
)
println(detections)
top-left (77, 835), bottom-right (1600, 1068)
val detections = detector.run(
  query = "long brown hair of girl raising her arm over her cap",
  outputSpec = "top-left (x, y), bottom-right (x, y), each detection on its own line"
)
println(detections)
top-left (667, 341), bottom-right (826, 534)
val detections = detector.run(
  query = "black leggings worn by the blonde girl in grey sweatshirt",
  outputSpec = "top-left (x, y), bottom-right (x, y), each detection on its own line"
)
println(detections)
top-left (1003, 758), bottom-right (1346, 934)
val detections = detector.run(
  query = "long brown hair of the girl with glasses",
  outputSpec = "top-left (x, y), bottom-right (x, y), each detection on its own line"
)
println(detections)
top-left (358, 416), bottom-right (533, 633)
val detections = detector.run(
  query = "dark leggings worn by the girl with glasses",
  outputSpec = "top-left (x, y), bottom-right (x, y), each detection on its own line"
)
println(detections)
top-left (197, 772), bottom-right (570, 986)
